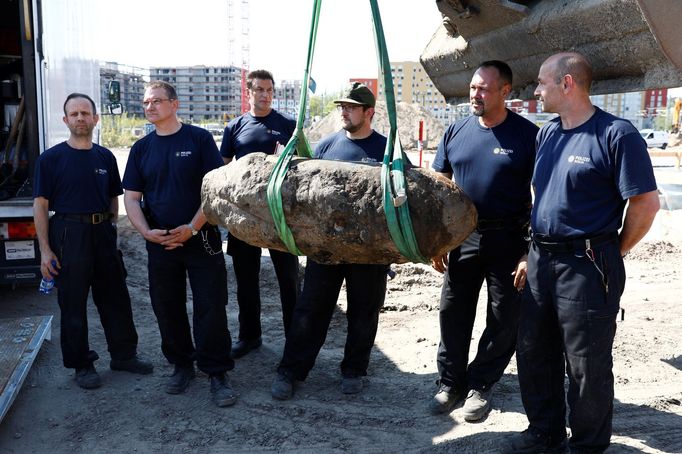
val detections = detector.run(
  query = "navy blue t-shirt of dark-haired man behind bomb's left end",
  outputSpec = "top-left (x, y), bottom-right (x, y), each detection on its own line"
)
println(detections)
top-left (220, 109), bottom-right (296, 159)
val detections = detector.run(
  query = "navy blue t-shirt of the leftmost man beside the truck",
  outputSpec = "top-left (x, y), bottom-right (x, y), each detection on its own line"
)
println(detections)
top-left (33, 142), bottom-right (123, 214)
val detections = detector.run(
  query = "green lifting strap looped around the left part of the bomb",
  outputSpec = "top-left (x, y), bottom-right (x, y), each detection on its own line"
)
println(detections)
top-left (267, 0), bottom-right (322, 255)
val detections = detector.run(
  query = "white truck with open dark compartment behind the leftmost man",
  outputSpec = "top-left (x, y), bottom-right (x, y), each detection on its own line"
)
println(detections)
top-left (0, 0), bottom-right (100, 286)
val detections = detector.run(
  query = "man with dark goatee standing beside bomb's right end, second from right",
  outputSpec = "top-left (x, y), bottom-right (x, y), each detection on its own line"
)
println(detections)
top-left (429, 60), bottom-right (538, 421)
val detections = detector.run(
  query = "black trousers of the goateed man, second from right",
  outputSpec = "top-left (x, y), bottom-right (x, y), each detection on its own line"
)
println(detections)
top-left (437, 230), bottom-right (527, 392)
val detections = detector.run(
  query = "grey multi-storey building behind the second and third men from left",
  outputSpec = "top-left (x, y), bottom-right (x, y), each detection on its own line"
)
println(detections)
top-left (150, 65), bottom-right (241, 123)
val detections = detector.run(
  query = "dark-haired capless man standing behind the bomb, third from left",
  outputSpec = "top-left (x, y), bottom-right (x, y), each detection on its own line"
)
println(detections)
top-left (220, 69), bottom-right (300, 358)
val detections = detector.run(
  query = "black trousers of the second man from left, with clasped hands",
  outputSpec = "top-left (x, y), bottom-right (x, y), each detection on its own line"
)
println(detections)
top-left (147, 226), bottom-right (234, 375)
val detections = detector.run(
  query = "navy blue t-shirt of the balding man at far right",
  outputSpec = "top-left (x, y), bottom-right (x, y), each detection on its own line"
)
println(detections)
top-left (531, 108), bottom-right (656, 240)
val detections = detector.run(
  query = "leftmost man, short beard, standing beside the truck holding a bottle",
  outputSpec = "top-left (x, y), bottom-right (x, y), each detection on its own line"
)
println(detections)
top-left (33, 93), bottom-right (153, 389)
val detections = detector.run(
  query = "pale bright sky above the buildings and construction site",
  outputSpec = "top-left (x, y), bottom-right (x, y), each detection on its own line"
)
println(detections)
top-left (95, 0), bottom-right (441, 94)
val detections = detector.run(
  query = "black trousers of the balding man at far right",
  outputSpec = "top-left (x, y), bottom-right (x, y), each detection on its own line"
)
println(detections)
top-left (516, 240), bottom-right (625, 452)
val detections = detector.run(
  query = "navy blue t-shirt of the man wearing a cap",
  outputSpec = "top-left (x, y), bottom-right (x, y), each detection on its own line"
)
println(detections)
top-left (314, 130), bottom-right (386, 162)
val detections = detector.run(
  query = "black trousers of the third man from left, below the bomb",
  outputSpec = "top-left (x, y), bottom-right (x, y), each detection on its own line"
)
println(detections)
top-left (227, 234), bottom-right (300, 340)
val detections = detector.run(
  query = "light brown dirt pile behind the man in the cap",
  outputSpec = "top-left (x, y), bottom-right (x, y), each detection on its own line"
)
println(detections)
top-left (306, 101), bottom-right (445, 149)
